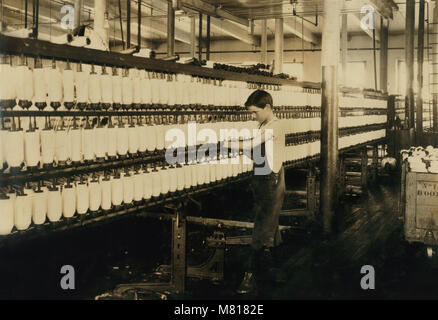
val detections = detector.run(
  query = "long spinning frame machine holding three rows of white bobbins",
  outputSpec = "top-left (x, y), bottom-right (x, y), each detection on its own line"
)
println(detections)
top-left (0, 35), bottom-right (387, 294)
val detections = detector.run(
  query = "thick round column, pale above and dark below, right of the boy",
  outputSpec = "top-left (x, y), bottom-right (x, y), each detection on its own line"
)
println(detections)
top-left (320, 0), bottom-right (343, 234)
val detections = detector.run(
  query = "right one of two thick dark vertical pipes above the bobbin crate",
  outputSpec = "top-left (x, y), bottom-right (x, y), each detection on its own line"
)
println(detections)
top-left (417, 0), bottom-right (425, 133)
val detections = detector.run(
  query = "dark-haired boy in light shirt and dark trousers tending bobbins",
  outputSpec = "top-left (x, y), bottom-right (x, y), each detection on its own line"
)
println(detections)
top-left (237, 90), bottom-right (285, 294)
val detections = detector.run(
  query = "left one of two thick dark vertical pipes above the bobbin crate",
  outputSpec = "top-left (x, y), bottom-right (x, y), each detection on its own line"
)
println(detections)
top-left (405, 0), bottom-right (415, 131)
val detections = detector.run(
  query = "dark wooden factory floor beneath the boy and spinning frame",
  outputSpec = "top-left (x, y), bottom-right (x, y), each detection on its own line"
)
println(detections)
top-left (0, 171), bottom-right (438, 299)
